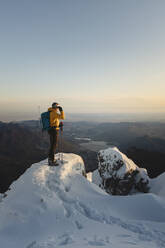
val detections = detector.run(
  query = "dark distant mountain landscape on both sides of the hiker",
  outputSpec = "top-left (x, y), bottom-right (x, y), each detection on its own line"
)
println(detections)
top-left (0, 120), bottom-right (165, 192)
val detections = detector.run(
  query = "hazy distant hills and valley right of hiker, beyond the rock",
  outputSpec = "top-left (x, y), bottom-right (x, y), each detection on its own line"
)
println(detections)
top-left (60, 122), bottom-right (165, 177)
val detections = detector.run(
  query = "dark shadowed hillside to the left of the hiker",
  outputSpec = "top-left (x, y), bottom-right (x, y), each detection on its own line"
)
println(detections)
top-left (0, 123), bottom-right (47, 192)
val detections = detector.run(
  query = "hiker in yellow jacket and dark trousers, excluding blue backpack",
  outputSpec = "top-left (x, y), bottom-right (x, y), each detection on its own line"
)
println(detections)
top-left (48, 102), bottom-right (65, 166)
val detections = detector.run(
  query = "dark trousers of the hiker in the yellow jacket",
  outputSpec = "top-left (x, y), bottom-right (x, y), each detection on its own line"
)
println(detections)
top-left (48, 128), bottom-right (59, 161)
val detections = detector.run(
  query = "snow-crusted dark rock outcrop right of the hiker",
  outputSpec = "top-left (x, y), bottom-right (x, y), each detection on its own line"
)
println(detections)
top-left (92, 147), bottom-right (149, 195)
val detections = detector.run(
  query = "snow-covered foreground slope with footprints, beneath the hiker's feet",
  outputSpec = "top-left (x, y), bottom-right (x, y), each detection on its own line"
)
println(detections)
top-left (0, 154), bottom-right (165, 248)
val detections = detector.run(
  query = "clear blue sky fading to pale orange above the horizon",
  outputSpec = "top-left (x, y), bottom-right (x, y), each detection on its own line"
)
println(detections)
top-left (0, 0), bottom-right (165, 120)
